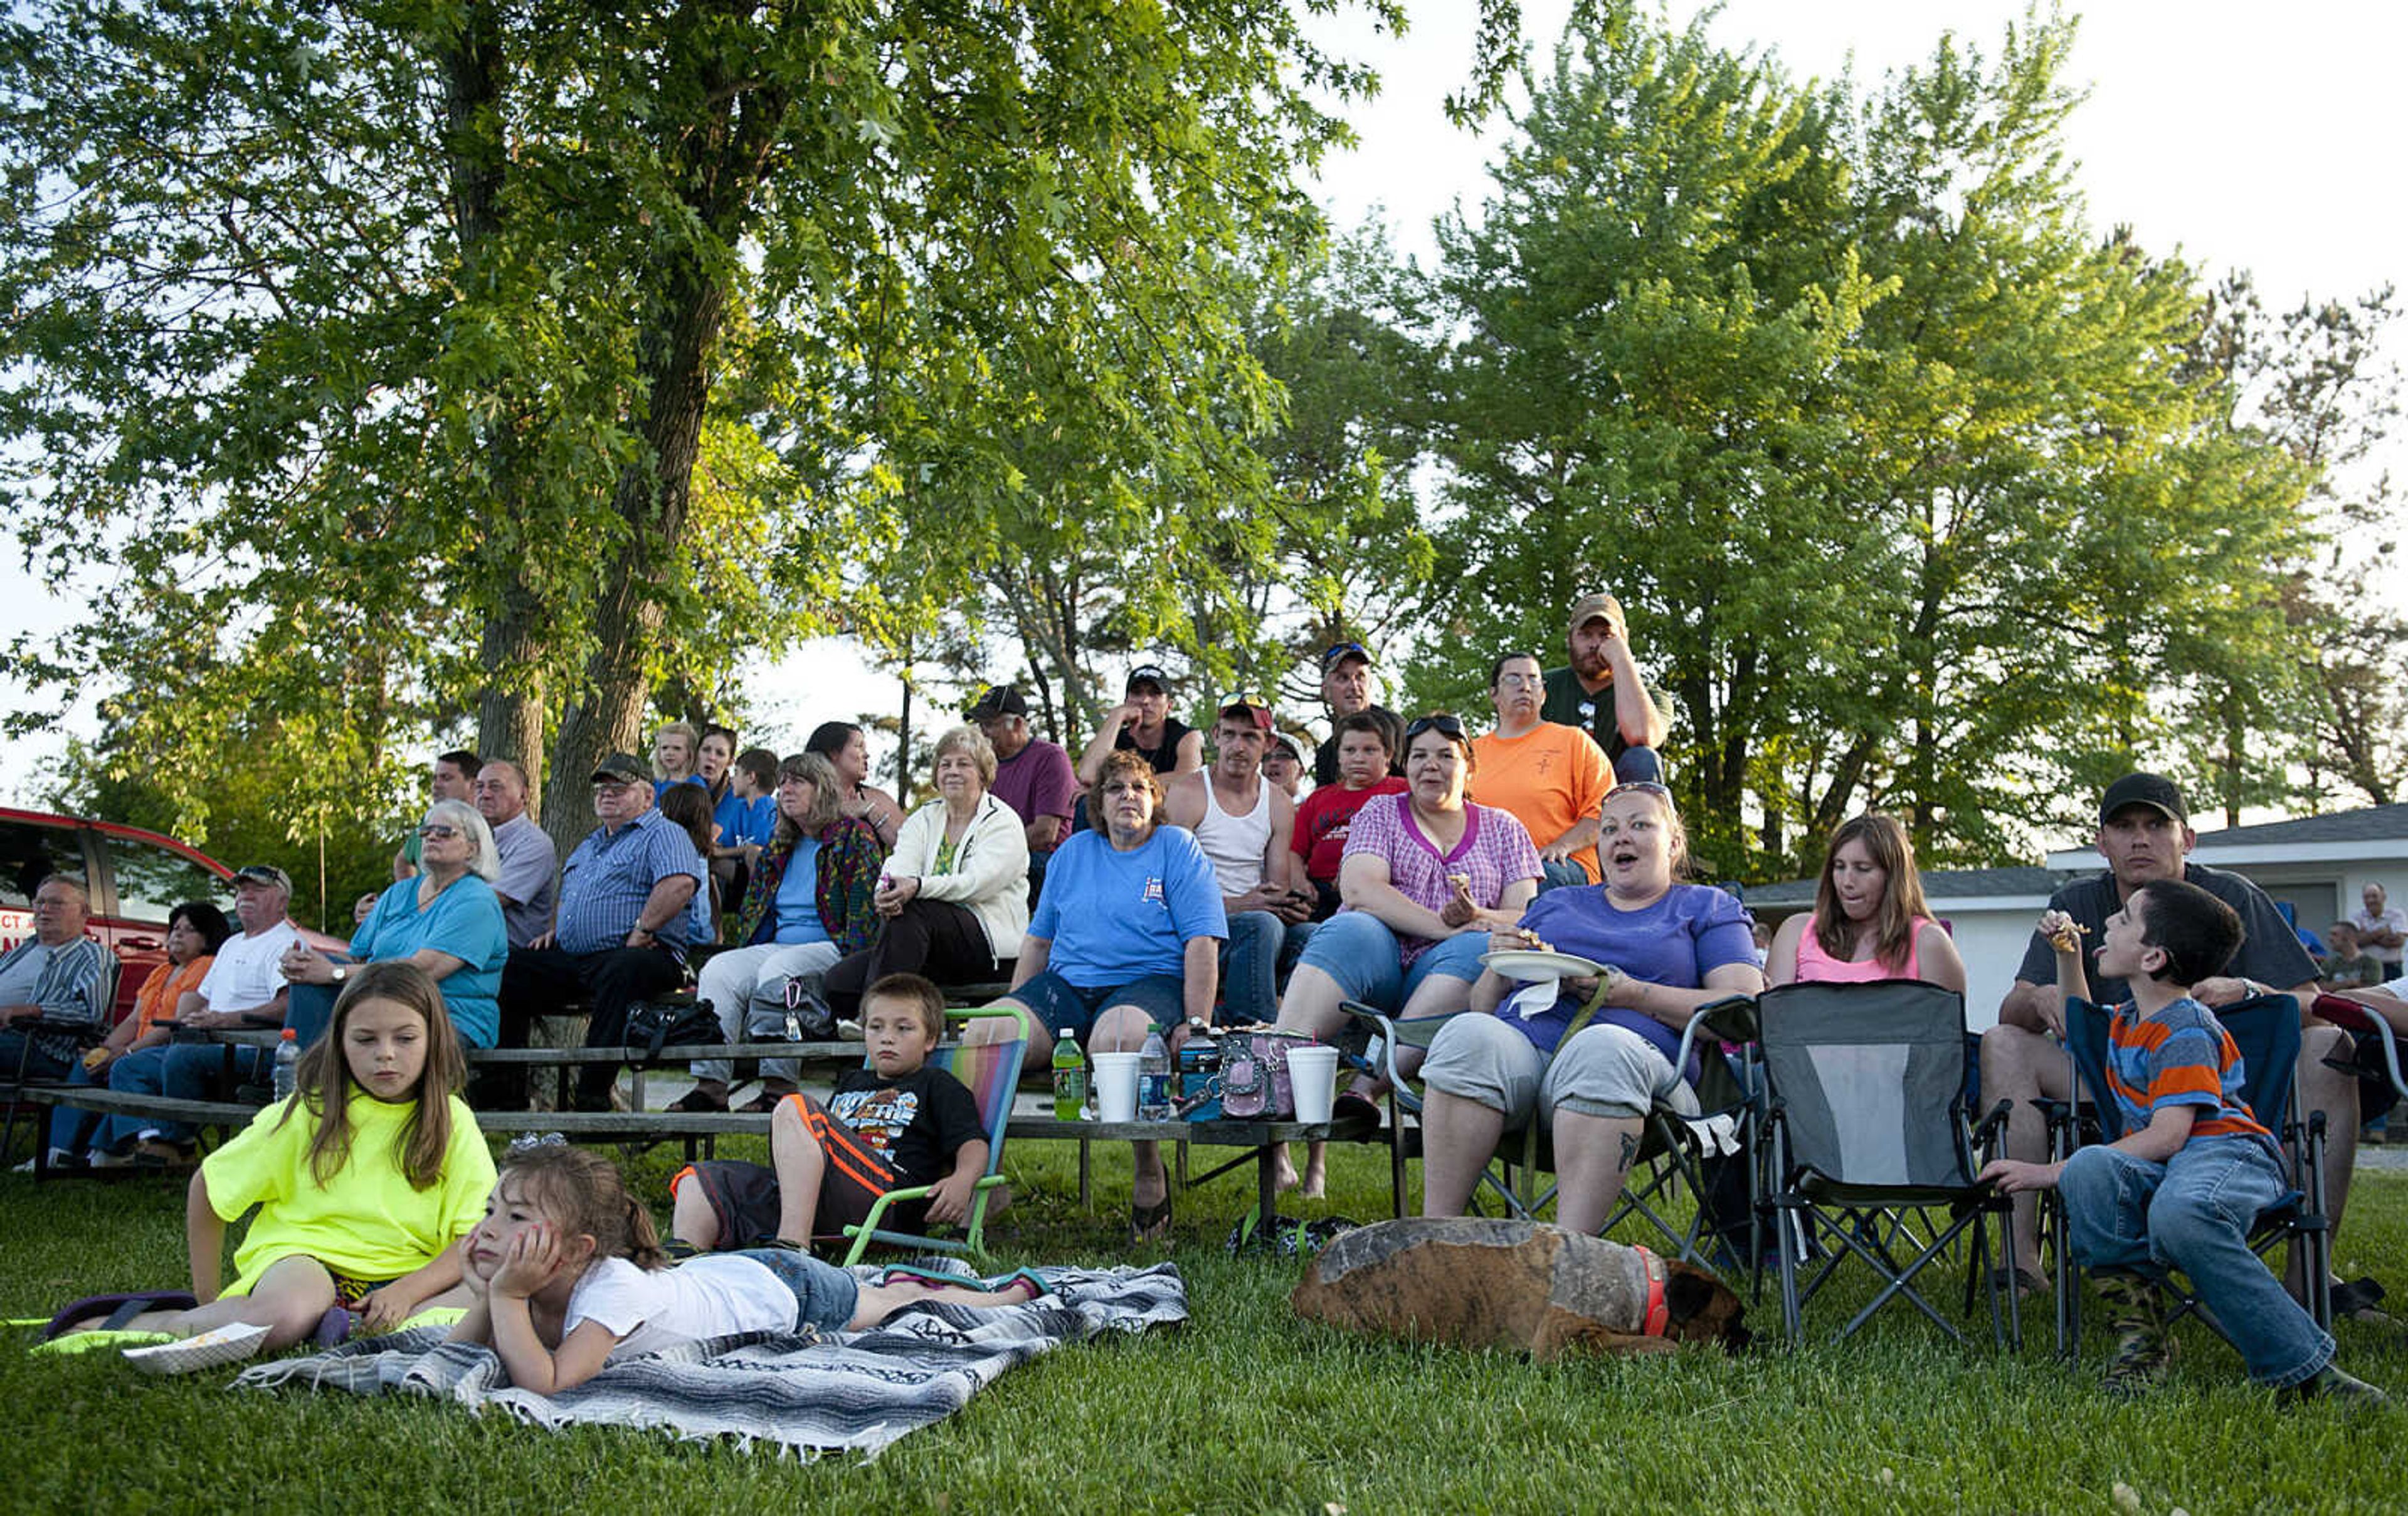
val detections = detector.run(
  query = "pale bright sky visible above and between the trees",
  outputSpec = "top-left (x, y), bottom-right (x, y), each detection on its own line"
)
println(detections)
top-left (0, 0), bottom-right (2408, 834)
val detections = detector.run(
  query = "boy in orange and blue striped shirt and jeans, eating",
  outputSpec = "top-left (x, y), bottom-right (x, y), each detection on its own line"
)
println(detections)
top-left (1982, 880), bottom-right (2384, 1401)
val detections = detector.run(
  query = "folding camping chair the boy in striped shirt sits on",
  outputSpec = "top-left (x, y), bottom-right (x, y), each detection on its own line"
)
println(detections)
top-left (2049, 995), bottom-right (2331, 1359)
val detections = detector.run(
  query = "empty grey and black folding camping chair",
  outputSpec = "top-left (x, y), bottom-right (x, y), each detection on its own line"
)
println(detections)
top-left (1758, 978), bottom-right (2023, 1347)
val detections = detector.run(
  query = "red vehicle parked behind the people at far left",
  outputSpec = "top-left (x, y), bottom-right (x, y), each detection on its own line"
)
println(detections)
top-left (0, 807), bottom-right (342, 1017)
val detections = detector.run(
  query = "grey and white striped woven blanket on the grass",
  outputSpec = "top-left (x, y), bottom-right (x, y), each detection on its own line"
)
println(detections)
top-left (233, 1263), bottom-right (1187, 1456)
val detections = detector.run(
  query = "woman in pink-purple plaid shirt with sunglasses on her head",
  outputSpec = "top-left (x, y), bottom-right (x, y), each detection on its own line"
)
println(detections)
top-left (1279, 716), bottom-right (1539, 1195)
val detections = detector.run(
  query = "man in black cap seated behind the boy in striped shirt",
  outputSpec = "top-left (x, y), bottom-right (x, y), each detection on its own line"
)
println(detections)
top-left (1982, 773), bottom-right (2357, 1290)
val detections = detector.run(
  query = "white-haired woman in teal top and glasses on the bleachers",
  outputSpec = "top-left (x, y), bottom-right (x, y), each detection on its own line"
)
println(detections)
top-left (282, 800), bottom-right (510, 1049)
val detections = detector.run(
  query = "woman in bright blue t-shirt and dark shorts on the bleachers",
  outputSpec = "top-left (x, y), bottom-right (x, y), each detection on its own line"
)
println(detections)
top-left (971, 750), bottom-right (1228, 1241)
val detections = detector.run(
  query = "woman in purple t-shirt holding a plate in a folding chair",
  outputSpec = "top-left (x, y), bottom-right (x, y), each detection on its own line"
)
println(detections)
top-left (1421, 783), bottom-right (1765, 1232)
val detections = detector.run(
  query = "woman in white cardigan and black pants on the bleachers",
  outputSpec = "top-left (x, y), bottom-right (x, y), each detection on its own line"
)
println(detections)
top-left (826, 726), bottom-right (1028, 1017)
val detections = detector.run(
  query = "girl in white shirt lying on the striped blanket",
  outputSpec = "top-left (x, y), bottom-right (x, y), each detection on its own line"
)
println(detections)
top-left (453, 1142), bottom-right (1047, 1396)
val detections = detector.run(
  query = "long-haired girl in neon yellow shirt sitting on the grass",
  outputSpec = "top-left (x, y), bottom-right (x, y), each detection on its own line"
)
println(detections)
top-left (51, 959), bottom-right (494, 1371)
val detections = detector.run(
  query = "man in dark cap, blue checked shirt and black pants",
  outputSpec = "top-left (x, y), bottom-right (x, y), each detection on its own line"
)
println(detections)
top-left (501, 752), bottom-right (710, 1111)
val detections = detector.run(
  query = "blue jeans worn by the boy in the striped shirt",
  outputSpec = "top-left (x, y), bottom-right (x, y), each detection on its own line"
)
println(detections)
top-left (2056, 1138), bottom-right (2333, 1388)
